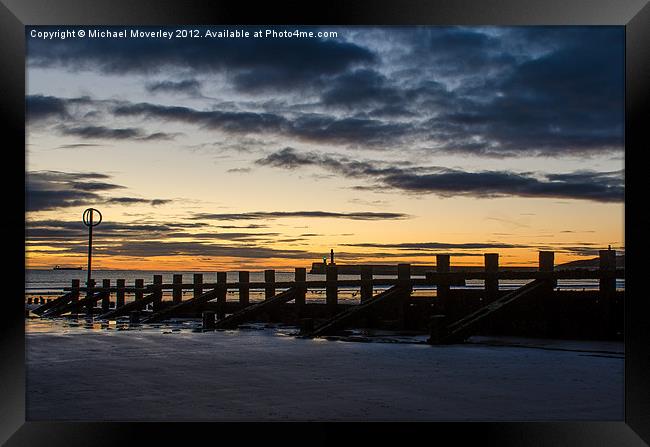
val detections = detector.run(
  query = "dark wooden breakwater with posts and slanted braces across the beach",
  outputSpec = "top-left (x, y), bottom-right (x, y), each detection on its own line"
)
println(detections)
top-left (27, 250), bottom-right (625, 343)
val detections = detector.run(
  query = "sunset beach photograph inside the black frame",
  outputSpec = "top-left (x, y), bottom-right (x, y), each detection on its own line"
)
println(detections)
top-left (25, 26), bottom-right (625, 421)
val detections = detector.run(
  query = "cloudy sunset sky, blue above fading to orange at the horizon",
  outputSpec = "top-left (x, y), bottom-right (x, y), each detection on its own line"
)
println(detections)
top-left (25, 26), bottom-right (625, 271)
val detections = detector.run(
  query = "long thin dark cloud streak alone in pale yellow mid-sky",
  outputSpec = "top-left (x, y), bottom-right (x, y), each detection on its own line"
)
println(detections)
top-left (193, 211), bottom-right (409, 220)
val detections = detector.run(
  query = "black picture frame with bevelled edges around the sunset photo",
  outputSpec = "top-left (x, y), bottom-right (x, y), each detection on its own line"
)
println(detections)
top-left (0, 0), bottom-right (650, 447)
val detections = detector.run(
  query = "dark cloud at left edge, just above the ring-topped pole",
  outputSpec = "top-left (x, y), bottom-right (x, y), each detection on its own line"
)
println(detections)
top-left (25, 171), bottom-right (169, 211)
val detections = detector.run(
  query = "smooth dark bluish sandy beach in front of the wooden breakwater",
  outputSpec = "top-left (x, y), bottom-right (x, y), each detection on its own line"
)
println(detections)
top-left (26, 320), bottom-right (624, 421)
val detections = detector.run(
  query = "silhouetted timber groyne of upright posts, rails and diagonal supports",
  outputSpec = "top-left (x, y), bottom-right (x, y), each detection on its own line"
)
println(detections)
top-left (28, 250), bottom-right (625, 342)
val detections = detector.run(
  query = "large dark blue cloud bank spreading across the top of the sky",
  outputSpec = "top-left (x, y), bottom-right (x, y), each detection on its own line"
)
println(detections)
top-left (27, 26), bottom-right (625, 160)
